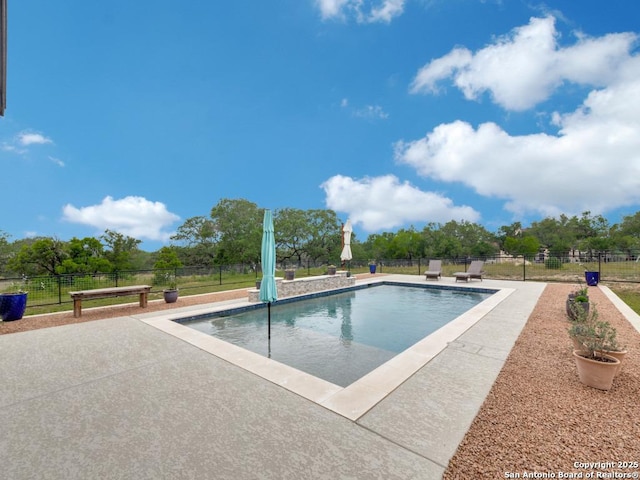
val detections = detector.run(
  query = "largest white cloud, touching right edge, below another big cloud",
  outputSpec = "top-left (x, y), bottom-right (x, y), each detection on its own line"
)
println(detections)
top-left (396, 52), bottom-right (640, 215)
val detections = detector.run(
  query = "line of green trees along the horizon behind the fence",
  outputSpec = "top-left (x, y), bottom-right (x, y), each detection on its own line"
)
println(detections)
top-left (0, 199), bottom-right (640, 277)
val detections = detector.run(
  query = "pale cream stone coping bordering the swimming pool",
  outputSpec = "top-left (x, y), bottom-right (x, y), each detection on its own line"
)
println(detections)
top-left (138, 279), bottom-right (515, 421)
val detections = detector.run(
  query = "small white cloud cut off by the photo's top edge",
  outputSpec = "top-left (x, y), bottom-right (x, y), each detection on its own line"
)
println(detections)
top-left (316, 0), bottom-right (406, 23)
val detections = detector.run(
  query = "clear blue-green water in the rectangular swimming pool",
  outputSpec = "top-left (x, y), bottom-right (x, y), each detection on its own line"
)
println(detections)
top-left (185, 285), bottom-right (491, 387)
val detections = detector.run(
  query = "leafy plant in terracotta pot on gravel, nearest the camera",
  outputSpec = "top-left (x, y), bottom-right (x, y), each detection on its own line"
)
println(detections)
top-left (569, 304), bottom-right (620, 390)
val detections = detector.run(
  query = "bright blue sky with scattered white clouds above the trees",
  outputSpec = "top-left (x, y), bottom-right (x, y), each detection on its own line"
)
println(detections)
top-left (0, 0), bottom-right (640, 250)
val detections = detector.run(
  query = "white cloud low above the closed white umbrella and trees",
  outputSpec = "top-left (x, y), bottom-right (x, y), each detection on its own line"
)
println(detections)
top-left (321, 175), bottom-right (480, 232)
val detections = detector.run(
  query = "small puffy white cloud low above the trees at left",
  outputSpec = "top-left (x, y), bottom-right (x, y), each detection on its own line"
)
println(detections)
top-left (63, 196), bottom-right (180, 241)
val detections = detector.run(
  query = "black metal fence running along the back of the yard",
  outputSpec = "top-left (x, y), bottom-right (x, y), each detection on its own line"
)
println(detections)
top-left (0, 254), bottom-right (640, 308)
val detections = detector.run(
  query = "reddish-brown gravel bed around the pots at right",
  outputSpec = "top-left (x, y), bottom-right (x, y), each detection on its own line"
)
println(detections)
top-left (444, 284), bottom-right (640, 479)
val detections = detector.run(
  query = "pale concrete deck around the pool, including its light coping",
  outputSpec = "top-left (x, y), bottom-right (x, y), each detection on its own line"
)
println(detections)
top-left (0, 275), bottom-right (545, 480)
